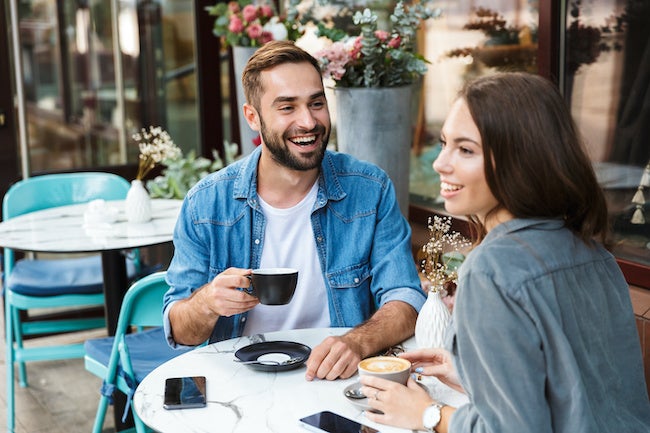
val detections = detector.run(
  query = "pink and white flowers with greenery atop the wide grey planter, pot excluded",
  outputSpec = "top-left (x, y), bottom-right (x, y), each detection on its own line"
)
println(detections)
top-left (314, 0), bottom-right (441, 87)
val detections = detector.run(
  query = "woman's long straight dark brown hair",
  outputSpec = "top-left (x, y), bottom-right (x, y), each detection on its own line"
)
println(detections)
top-left (460, 72), bottom-right (608, 243)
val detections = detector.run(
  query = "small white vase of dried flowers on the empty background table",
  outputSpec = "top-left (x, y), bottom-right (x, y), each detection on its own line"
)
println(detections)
top-left (124, 126), bottom-right (181, 223)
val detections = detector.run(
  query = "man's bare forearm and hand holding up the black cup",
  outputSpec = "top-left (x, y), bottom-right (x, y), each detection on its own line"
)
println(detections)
top-left (169, 268), bottom-right (259, 346)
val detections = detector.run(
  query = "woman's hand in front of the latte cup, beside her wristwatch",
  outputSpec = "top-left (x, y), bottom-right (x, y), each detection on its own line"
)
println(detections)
top-left (361, 376), bottom-right (434, 430)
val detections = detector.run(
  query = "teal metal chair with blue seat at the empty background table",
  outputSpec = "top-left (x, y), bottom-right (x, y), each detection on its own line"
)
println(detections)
top-left (2, 172), bottom-right (139, 432)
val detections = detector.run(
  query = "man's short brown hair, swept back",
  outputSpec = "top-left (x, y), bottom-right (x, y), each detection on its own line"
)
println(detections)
top-left (242, 41), bottom-right (321, 110)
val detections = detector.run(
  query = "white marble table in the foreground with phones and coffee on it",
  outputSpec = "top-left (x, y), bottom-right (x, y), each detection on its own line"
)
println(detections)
top-left (133, 328), bottom-right (467, 433)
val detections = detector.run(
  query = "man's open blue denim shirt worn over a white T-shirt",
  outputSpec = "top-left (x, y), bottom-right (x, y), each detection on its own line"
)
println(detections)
top-left (163, 148), bottom-right (426, 346)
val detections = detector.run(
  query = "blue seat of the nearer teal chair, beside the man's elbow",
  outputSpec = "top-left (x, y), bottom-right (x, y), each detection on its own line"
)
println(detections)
top-left (84, 328), bottom-right (192, 383)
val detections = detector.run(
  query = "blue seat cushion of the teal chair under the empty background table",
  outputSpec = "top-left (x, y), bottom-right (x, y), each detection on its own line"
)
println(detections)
top-left (7, 255), bottom-right (136, 296)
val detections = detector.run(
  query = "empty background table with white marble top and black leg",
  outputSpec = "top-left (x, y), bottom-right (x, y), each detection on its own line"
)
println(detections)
top-left (0, 199), bottom-right (182, 335)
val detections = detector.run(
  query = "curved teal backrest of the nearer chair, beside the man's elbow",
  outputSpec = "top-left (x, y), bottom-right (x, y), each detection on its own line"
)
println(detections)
top-left (115, 271), bottom-right (169, 335)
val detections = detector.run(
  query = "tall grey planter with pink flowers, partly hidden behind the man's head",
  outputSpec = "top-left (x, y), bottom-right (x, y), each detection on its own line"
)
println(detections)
top-left (206, 0), bottom-right (301, 155)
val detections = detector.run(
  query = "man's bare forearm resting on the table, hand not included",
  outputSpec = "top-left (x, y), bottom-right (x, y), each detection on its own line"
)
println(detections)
top-left (344, 301), bottom-right (418, 358)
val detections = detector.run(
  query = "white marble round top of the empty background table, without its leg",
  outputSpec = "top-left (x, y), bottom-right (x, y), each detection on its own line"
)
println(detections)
top-left (0, 199), bottom-right (183, 253)
